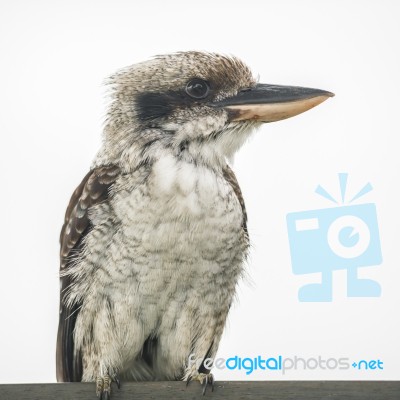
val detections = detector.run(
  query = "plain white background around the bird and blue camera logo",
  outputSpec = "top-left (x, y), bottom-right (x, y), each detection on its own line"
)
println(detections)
top-left (0, 0), bottom-right (400, 382)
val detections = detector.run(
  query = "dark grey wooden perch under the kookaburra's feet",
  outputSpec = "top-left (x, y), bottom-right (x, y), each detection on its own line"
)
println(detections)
top-left (0, 381), bottom-right (400, 400)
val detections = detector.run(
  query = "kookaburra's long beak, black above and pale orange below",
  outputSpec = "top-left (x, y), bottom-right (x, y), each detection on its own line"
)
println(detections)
top-left (212, 84), bottom-right (334, 122)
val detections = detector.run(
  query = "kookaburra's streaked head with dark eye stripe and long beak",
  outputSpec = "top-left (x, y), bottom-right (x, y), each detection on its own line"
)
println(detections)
top-left (101, 51), bottom-right (332, 169)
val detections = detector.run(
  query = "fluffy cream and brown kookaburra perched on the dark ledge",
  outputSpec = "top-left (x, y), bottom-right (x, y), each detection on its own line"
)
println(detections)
top-left (56, 51), bottom-right (333, 400)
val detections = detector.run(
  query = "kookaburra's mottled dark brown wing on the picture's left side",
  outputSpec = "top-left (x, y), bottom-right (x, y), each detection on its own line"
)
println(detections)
top-left (56, 165), bottom-right (120, 382)
